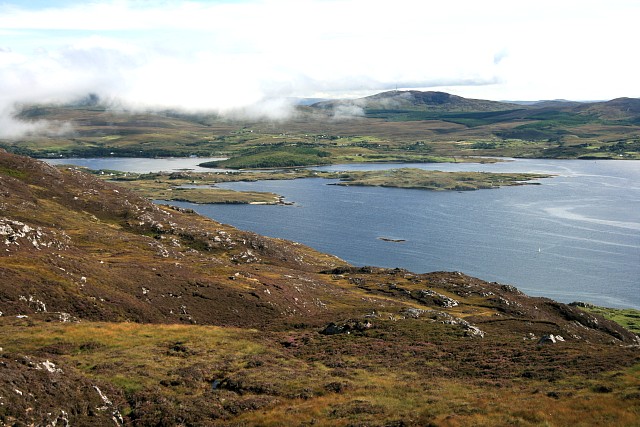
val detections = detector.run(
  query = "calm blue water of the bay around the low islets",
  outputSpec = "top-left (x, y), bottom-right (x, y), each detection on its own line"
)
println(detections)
top-left (45, 159), bottom-right (640, 309)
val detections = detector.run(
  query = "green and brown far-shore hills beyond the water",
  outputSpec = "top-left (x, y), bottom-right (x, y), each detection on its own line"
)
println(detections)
top-left (0, 91), bottom-right (640, 167)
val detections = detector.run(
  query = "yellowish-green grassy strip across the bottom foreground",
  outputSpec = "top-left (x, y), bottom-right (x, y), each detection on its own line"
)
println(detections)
top-left (0, 318), bottom-right (640, 426)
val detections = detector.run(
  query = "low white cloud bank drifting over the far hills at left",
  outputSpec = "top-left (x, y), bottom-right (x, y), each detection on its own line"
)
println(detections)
top-left (0, 37), bottom-right (491, 138)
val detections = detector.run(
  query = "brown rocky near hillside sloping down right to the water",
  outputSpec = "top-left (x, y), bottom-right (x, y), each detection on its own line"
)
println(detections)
top-left (0, 151), bottom-right (640, 426)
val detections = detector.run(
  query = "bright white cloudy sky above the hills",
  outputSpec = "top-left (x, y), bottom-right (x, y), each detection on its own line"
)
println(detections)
top-left (0, 0), bottom-right (640, 137)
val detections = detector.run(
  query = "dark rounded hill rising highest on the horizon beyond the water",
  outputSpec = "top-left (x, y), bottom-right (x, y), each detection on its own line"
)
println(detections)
top-left (312, 90), bottom-right (523, 112)
